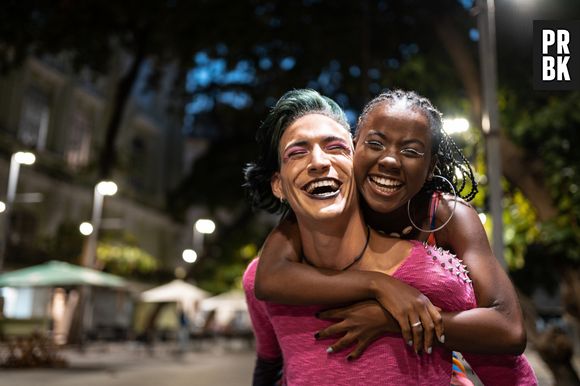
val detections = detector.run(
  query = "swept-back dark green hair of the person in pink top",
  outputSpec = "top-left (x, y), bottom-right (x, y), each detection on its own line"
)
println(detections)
top-left (243, 89), bottom-right (350, 214)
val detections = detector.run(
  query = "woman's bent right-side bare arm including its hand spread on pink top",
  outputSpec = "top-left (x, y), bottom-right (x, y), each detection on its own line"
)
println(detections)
top-left (319, 203), bottom-right (526, 358)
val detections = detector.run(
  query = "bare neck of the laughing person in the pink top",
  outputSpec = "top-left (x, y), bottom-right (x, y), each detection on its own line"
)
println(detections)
top-left (298, 206), bottom-right (368, 270)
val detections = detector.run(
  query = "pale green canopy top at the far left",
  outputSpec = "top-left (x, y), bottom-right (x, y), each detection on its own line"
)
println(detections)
top-left (0, 261), bottom-right (126, 287)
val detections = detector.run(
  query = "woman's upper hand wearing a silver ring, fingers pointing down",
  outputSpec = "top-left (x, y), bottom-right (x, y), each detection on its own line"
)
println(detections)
top-left (374, 277), bottom-right (445, 353)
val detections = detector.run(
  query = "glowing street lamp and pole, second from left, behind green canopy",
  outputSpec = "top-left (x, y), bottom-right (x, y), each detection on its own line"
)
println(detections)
top-left (80, 181), bottom-right (117, 268)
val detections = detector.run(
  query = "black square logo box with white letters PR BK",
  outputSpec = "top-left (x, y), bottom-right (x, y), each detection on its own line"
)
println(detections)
top-left (533, 20), bottom-right (580, 91)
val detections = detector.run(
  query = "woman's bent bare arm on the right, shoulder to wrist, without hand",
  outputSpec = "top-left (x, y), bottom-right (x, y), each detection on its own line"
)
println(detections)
top-left (437, 203), bottom-right (526, 354)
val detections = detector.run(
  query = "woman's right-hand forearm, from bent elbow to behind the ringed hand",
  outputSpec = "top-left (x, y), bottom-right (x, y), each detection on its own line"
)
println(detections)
top-left (441, 307), bottom-right (526, 355)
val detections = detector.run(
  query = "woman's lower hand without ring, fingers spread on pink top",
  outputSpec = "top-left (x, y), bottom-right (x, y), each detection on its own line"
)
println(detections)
top-left (316, 300), bottom-right (399, 360)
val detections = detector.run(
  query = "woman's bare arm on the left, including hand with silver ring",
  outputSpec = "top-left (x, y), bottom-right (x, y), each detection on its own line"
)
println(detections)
top-left (255, 216), bottom-right (444, 351)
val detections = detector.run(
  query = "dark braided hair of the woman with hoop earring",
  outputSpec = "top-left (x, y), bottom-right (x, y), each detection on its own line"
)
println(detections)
top-left (355, 90), bottom-right (478, 201)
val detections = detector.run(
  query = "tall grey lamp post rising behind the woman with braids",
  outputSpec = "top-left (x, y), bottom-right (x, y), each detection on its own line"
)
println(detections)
top-left (476, 0), bottom-right (506, 268)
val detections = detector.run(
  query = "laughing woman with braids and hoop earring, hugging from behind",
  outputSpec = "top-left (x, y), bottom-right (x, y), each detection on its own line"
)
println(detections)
top-left (255, 90), bottom-right (537, 385)
